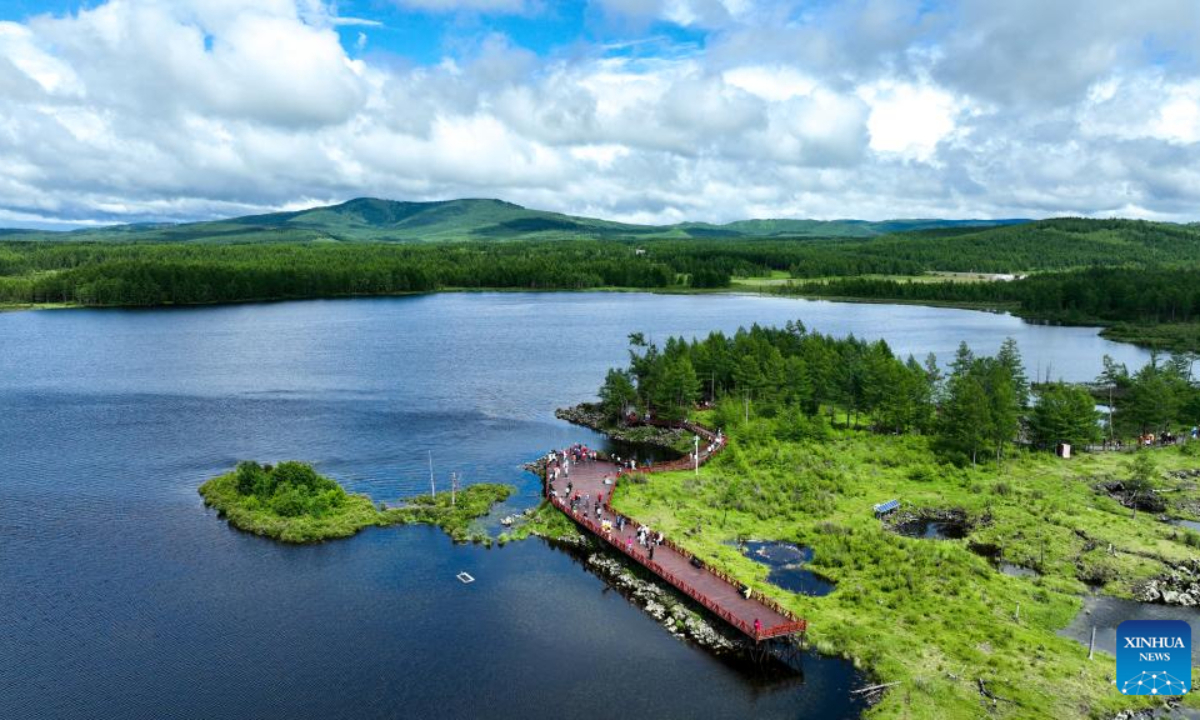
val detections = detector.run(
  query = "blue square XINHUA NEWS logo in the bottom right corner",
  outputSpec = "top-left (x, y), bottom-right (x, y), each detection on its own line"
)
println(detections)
top-left (1116, 620), bottom-right (1192, 695)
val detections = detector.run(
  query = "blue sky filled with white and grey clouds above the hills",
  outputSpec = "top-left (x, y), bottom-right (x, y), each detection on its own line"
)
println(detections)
top-left (0, 0), bottom-right (1200, 227)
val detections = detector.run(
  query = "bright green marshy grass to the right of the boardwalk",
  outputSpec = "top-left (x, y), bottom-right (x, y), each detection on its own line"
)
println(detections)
top-left (614, 420), bottom-right (1200, 719)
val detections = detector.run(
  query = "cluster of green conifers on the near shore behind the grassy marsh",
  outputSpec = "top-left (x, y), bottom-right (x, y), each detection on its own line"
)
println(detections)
top-left (599, 323), bottom-right (1200, 464)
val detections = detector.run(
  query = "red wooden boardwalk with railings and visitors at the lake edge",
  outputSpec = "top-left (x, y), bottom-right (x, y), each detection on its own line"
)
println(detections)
top-left (546, 426), bottom-right (806, 642)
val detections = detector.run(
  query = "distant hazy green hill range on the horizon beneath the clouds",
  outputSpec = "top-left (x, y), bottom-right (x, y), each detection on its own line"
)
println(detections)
top-left (0, 198), bottom-right (1025, 242)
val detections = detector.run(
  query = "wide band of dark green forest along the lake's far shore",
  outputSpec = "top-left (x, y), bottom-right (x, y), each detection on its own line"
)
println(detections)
top-left (7, 218), bottom-right (1200, 350)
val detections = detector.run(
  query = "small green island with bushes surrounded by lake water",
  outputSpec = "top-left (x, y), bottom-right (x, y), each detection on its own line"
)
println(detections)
top-left (199, 461), bottom-right (512, 544)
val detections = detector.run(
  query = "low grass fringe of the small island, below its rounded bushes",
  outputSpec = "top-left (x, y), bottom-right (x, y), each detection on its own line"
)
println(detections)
top-left (199, 473), bottom-right (512, 542)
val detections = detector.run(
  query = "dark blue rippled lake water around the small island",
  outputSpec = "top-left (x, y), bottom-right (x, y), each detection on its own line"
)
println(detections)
top-left (0, 294), bottom-right (1145, 720)
